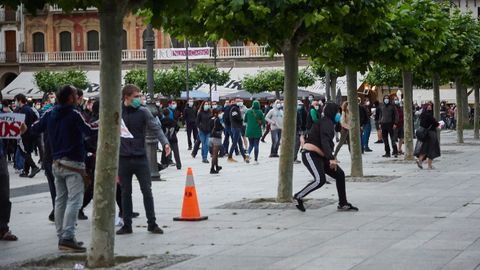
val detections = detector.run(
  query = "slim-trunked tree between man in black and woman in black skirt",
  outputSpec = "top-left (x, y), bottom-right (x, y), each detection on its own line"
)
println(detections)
top-left (376, 0), bottom-right (448, 160)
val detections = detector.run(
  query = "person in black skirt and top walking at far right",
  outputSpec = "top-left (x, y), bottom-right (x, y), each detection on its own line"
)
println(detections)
top-left (414, 102), bottom-right (440, 169)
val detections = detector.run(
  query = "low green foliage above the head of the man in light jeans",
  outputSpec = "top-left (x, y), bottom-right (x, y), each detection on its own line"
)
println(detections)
top-left (33, 70), bottom-right (89, 92)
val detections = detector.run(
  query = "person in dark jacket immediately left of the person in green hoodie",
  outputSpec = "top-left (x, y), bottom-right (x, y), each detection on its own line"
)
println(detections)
top-left (228, 98), bottom-right (250, 163)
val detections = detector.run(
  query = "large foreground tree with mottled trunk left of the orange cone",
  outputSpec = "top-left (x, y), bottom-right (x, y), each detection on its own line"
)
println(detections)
top-left (7, 0), bottom-right (191, 268)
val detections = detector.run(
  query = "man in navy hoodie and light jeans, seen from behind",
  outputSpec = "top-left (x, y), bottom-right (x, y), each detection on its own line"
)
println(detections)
top-left (31, 85), bottom-right (96, 252)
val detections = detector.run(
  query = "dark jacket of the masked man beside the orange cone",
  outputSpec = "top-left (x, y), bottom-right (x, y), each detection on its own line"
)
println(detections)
top-left (120, 105), bottom-right (168, 157)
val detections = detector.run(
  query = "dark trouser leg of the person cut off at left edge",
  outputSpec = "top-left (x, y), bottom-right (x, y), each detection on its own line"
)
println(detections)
top-left (0, 155), bottom-right (12, 233)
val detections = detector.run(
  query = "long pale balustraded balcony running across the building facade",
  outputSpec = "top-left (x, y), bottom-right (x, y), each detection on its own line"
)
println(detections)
top-left (19, 46), bottom-right (281, 64)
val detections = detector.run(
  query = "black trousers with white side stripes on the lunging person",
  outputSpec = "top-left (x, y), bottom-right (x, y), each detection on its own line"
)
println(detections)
top-left (295, 151), bottom-right (347, 205)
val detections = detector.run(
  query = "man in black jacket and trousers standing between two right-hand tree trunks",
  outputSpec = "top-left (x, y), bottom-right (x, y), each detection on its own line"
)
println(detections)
top-left (380, 95), bottom-right (398, 157)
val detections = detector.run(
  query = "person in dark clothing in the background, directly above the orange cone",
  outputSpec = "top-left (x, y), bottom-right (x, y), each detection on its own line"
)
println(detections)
top-left (160, 108), bottom-right (182, 170)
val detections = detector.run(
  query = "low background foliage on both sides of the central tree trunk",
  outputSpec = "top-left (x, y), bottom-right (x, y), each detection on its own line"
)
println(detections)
top-left (242, 69), bottom-right (315, 95)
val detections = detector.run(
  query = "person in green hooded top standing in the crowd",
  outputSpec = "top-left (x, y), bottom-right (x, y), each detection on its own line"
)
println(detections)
top-left (244, 100), bottom-right (265, 165)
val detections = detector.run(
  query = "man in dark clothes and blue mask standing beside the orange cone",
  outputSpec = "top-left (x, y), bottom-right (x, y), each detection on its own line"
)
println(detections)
top-left (117, 84), bottom-right (171, 235)
